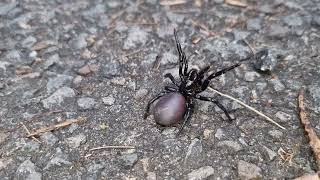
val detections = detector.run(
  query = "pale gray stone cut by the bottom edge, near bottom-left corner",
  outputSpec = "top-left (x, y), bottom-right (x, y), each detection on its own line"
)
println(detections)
top-left (15, 160), bottom-right (42, 180)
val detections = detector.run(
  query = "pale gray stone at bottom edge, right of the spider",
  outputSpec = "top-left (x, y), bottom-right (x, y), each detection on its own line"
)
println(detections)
top-left (238, 160), bottom-right (262, 179)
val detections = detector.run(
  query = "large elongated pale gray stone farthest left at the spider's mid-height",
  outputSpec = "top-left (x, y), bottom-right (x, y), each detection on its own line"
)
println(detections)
top-left (41, 86), bottom-right (76, 109)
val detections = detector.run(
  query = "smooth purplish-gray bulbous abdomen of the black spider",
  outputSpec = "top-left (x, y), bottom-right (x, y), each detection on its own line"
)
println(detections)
top-left (153, 93), bottom-right (186, 126)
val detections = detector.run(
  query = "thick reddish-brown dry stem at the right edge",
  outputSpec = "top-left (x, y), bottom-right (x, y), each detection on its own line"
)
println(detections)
top-left (298, 88), bottom-right (320, 170)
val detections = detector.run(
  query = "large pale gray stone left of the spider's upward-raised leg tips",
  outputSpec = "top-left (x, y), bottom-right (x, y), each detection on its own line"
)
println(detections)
top-left (123, 27), bottom-right (148, 50)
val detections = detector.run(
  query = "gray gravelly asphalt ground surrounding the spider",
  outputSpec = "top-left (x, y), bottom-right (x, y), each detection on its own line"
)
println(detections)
top-left (0, 0), bottom-right (320, 180)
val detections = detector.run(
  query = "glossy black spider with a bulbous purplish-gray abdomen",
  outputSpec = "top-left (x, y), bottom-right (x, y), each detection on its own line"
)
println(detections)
top-left (144, 30), bottom-right (251, 133)
